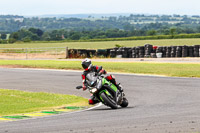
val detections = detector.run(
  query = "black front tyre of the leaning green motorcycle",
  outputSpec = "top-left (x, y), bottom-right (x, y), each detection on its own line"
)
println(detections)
top-left (100, 92), bottom-right (118, 109)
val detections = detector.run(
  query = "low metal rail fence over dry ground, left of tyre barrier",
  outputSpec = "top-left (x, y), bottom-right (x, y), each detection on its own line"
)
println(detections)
top-left (0, 47), bottom-right (68, 59)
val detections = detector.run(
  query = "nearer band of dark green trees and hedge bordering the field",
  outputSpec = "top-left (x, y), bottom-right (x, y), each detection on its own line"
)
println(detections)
top-left (0, 28), bottom-right (200, 43)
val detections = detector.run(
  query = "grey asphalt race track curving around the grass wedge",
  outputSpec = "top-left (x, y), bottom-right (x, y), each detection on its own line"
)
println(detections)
top-left (0, 68), bottom-right (200, 133)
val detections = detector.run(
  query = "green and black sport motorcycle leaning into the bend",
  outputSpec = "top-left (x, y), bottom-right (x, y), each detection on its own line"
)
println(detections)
top-left (76, 67), bottom-right (128, 109)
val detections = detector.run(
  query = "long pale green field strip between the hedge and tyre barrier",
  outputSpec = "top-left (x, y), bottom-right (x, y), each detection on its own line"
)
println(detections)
top-left (0, 38), bottom-right (200, 49)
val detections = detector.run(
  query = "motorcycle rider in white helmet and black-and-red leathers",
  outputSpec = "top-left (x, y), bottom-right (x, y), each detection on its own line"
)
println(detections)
top-left (82, 58), bottom-right (124, 105)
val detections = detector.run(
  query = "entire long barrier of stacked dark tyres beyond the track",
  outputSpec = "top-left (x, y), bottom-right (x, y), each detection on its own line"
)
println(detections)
top-left (68, 44), bottom-right (200, 58)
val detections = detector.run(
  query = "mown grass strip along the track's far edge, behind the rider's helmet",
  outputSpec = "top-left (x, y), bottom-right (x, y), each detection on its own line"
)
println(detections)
top-left (0, 60), bottom-right (200, 77)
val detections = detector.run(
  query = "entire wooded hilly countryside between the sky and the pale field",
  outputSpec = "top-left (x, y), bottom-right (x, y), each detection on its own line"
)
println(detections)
top-left (0, 14), bottom-right (200, 43)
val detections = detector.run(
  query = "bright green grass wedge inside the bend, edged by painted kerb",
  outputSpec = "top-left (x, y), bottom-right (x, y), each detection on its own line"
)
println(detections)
top-left (0, 89), bottom-right (87, 116)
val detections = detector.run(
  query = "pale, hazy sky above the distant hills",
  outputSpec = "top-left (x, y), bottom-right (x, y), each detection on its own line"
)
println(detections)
top-left (0, 0), bottom-right (200, 16)
